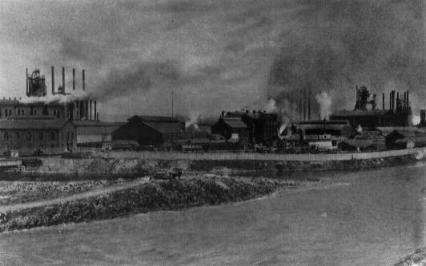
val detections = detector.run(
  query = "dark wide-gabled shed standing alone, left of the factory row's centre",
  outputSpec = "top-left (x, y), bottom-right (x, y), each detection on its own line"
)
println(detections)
top-left (112, 116), bottom-right (185, 146)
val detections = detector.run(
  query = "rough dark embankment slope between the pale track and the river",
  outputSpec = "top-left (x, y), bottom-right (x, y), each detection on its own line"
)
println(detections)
top-left (0, 176), bottom-right (312, 232)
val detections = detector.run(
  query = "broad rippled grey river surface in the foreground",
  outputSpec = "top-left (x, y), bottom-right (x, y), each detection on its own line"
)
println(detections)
top-left (0, 163), bottom-right (426, 265)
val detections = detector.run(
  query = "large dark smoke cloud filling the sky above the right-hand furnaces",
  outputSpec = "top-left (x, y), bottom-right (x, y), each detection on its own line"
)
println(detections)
top-left (268, 0), bottom-right (426, 115)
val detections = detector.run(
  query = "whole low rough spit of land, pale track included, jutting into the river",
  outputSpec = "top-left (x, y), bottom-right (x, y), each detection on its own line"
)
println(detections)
top-left (0, 174), bottom-right (321, 232)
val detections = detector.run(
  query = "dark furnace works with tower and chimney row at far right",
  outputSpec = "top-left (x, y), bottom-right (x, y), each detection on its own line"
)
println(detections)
top-left (330, 87), bottom-right (412, 128)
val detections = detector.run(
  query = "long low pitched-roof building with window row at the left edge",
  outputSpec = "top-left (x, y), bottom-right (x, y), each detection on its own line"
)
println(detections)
top-left (0, 117), bottom-right (77, 155)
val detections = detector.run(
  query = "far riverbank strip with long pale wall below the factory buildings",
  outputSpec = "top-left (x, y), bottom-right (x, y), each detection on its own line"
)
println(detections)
top-left (2, 148), bottom-right (426, 180)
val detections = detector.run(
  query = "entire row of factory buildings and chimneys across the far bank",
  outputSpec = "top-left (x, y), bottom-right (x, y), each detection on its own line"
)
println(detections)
top-left (0, 66), bottom-right (426, 155)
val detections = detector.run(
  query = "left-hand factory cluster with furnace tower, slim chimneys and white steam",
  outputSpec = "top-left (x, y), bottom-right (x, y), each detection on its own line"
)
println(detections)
top-left (0, 66), bottom-right (120, 154)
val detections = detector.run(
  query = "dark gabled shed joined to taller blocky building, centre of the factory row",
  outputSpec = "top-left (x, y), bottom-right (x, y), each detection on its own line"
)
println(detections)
top-left (212, 110), bottom-right (278, 145)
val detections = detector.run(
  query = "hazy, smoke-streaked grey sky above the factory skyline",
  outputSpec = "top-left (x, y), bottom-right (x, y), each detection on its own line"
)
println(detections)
top-left (0, 0), bottom-right (426, 120)
